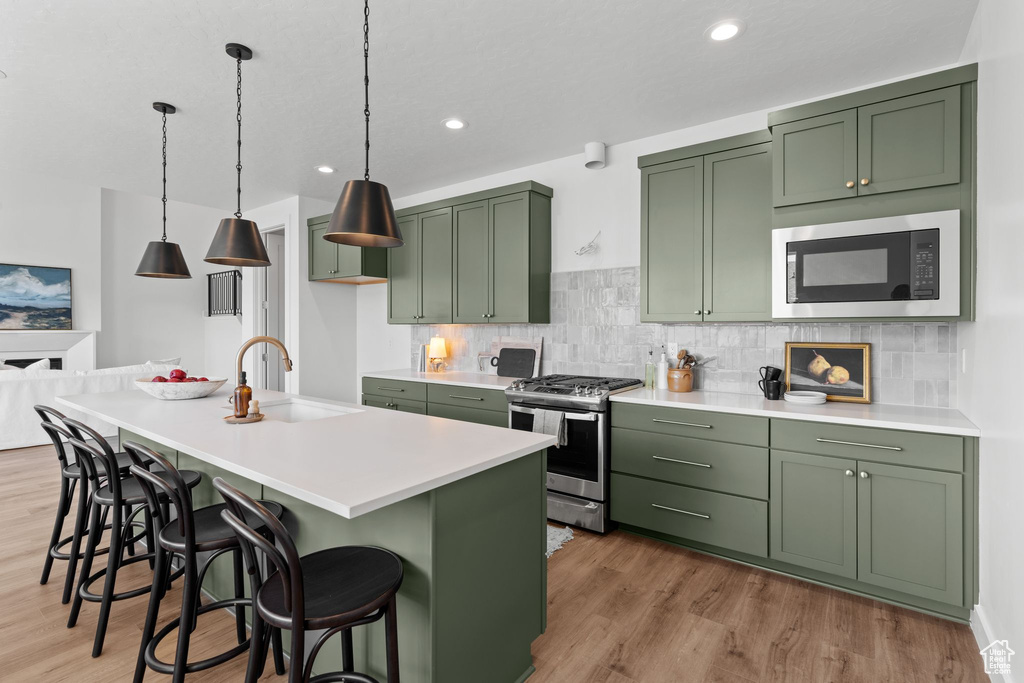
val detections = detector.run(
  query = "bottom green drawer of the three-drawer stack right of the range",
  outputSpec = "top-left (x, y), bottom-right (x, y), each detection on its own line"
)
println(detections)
top-left (611, 473), bottom-right (768, 557)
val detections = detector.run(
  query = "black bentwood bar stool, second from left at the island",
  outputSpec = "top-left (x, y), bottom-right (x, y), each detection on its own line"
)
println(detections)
top-left (65, 418), bottom-right (203, 657)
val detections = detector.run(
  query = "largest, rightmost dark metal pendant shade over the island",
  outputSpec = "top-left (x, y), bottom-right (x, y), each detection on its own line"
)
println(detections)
top-left (324, 180), bottom-right (403, 247)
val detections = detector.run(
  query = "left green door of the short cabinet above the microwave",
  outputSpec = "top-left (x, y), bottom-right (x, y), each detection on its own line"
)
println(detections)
top-left (772, 110), bottom-right (857, 207)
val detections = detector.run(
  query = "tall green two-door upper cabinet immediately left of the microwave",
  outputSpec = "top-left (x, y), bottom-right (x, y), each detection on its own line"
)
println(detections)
top-left (639, 132), bottom-right (771, 323)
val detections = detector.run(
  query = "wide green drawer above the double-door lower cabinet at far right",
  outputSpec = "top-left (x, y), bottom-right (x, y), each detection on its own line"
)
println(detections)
top-left (771, 420), bottom-right (964, 472)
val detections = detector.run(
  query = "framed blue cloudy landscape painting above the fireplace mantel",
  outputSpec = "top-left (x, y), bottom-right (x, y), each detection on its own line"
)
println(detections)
top-left (0, 263), bottom-right (72, 331)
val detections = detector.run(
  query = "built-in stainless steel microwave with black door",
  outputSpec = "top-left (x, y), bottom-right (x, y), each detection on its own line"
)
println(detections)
top-left (771, 210), bottom-right (959, 318)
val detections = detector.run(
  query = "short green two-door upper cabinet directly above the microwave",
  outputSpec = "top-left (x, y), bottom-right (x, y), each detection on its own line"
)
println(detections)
top-left (772, 85), bottom-right (961, 207)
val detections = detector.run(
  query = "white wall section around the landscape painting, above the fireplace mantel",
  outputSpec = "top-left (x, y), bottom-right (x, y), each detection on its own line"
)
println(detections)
top-left (0, 168), bottom-right (102, 330)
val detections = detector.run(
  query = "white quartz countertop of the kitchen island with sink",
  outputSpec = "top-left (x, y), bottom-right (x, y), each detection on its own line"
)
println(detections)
top-left (57, 387), bottom-right (555, 518)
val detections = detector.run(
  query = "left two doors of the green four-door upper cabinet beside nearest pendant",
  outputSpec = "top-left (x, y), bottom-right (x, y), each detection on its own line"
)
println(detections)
top-left (387, 208), bottom-right (453, 324)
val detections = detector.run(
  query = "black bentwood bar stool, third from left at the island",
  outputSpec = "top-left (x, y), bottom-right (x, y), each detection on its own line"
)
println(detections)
top-left (124, 441), bottom-right (285, 683)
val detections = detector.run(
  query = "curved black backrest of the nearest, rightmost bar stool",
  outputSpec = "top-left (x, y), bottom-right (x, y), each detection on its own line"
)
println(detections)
top-left (213, 477), bottom-right (305, 618)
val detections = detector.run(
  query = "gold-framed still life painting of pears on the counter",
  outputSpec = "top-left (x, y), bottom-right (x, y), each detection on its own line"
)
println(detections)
top-left (785, 342), bottom-right (871, 403)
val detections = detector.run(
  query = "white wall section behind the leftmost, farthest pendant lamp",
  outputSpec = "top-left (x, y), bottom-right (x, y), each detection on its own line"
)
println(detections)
top-left (97, 189), bottom-right (228, 377)
